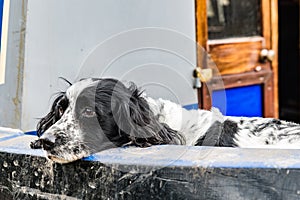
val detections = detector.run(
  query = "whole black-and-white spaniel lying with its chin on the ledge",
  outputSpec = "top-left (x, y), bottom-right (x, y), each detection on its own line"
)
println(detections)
top-left (31, 78), bottom-right (300, 163)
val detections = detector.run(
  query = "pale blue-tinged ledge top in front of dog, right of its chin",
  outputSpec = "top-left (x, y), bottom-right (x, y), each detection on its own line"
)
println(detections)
top-left (83, 145), bottom-right (300, 169)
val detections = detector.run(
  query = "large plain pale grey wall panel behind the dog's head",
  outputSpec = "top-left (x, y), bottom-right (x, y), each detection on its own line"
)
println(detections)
top-left (21, 0), bottom-right (197, 131)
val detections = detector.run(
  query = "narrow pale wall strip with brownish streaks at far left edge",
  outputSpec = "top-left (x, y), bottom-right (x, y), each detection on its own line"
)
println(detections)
top-left (0, 0), bottom-right (27, 128)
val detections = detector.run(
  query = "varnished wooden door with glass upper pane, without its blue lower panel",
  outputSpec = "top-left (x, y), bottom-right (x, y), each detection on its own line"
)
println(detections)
top-left (196, 0), bottom-right (278, 117)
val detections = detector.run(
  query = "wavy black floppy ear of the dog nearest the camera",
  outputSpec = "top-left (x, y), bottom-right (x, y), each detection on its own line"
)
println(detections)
top-left (111, 82), bottom-right (184, 147)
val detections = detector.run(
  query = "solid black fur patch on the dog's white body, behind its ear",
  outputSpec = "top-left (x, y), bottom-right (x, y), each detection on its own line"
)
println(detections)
top-left (196, 120), bottom-right (238, 147)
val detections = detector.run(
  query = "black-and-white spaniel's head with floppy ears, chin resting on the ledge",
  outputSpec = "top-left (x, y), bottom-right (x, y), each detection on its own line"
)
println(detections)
top-left (32, 79), bottom-right (184, 163)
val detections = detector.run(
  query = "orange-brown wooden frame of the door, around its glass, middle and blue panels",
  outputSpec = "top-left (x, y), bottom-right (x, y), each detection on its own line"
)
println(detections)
top-left (195, 0), bottom-right (278, 118)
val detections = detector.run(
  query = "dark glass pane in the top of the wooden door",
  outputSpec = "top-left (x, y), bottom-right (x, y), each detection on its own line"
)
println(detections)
top-left (207, 0), bottom-right (262, 39)
